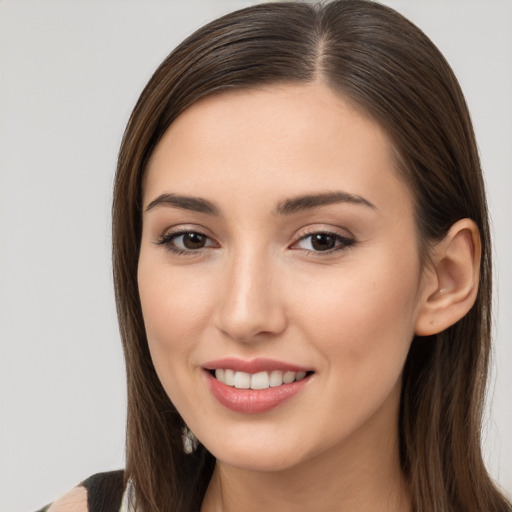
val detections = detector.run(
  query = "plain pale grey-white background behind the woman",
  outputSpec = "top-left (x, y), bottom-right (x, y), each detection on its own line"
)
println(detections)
top-left (0, 0), bottom-right (512, 512)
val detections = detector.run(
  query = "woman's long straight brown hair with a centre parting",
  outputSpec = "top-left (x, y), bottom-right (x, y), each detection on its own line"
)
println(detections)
top-left (113, 0), bottom-right (511, 512)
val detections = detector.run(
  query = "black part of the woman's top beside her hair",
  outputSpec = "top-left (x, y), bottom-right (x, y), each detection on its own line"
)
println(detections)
top-left (80, 470), bottom-right (124, 512)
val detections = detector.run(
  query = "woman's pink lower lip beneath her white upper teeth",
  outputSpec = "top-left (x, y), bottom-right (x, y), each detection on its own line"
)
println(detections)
top-left (206, 372), bottom-right (310, 414)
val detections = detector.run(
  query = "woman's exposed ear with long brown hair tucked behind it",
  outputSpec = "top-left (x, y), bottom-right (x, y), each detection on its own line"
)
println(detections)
top-left (415, 219), bottom-right (481, 336)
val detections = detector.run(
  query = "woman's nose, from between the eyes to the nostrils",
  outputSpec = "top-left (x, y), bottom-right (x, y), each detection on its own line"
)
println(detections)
top-left (215, 249), bottom-right (287, 343)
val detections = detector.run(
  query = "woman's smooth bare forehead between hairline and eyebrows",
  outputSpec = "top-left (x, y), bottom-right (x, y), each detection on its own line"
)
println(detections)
top-left (144, 84), bottom-right (409, 216)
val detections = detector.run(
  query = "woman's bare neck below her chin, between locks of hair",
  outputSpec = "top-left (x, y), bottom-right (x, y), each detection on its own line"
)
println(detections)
top-left (201, 390), bottom-right (411, 512)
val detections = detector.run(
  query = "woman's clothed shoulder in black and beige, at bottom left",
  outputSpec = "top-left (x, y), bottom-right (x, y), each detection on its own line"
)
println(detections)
top-left (40, 470), bottom-right (124, 512)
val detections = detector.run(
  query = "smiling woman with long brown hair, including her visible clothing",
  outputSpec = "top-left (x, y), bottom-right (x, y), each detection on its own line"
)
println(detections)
top-left (43, 0), bottom-right (511, 512)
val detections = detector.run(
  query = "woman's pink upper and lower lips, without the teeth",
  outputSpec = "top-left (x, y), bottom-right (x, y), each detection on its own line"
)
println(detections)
top-left (203, 358), bottom-right (312, 414)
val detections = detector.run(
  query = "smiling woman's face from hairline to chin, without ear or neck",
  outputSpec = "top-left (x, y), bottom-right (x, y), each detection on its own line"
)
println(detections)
top-left (138, 84), bottom-right (421, 470)
